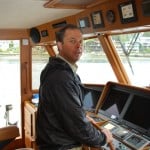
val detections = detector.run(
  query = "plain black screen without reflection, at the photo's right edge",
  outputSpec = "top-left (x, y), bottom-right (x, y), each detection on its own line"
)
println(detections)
top-left (123, 95), bottom-right (150, 131)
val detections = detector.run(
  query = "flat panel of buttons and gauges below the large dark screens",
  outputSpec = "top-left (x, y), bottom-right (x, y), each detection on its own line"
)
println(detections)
top-left (102, 121), bottom-right (150, 150)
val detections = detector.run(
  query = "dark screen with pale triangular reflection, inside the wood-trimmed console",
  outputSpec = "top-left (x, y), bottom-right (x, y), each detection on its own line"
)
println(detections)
top-left (100, 86), bottom-right (130, 119)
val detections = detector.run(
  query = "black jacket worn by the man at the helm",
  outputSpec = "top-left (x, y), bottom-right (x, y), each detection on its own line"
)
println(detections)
top-left (36, 57), bottom-right (106, 150)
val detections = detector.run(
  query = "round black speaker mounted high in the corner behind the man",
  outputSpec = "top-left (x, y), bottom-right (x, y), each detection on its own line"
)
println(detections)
top-left (30, 27), bottom-right (41, 43)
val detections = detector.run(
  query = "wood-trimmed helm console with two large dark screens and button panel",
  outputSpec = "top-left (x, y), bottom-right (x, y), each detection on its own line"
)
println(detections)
top-left (87, 82), bottom-right (150, 150)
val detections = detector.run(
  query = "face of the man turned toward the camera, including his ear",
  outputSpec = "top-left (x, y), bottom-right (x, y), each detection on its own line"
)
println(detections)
top-left (58, 29), bottom-right (83, 64)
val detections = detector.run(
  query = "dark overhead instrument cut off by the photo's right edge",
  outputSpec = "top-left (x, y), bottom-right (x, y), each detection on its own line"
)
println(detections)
top-left (142, 0), bottom-right (150, 16)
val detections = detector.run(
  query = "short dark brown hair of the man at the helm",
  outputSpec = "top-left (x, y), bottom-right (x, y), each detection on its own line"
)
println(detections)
top-left (56, 24), bottom-right (80, 42)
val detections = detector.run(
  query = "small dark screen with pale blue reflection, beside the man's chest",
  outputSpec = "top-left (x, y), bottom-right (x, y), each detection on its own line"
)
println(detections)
top-left (83, 89), bottom-right (101, 111)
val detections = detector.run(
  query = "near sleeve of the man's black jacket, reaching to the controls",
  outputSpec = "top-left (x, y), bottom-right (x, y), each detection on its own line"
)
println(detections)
top-left (53, 77), bottom-right (106, 147)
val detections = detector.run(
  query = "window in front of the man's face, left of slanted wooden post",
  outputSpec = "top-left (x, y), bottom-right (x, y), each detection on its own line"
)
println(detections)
top-left (77, 38), bottom-right (117, 84)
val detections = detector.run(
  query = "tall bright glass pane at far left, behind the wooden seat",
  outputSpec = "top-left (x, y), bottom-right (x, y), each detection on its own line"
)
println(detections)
top-left (0, 40), bottom-right (21, 127)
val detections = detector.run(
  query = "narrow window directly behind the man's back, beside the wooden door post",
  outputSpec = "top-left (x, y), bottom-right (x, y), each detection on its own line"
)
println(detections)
top-left (32, 46), bottom-right (49, 89)
